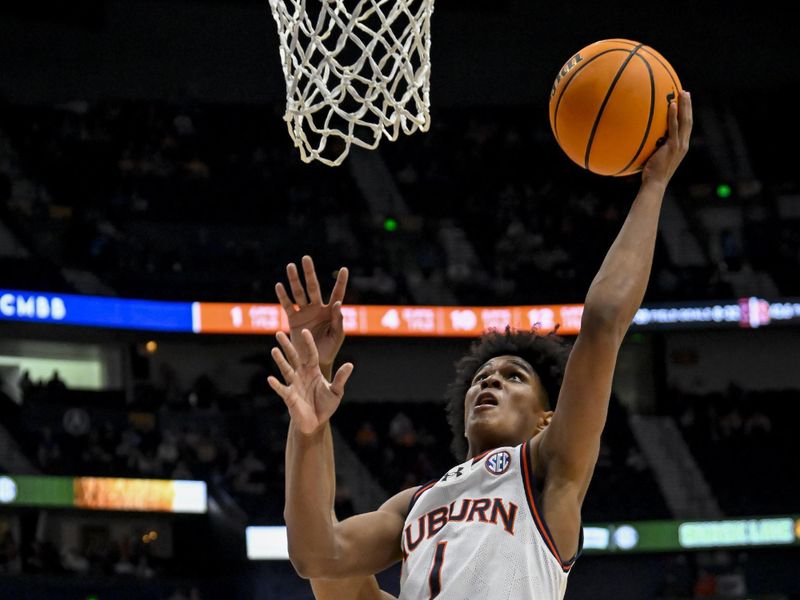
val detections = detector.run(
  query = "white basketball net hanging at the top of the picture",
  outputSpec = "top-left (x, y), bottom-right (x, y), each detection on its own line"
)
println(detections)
top-left (269, 0), bottom-right (434, 166)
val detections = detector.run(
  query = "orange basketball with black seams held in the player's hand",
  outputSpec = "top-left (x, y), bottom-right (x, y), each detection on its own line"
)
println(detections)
top-left (550, 39), bottom-right (681, 176)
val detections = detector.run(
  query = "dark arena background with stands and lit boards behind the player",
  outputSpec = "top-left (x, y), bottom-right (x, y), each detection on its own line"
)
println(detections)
top-left (0, 0), bottom-right (800, 600)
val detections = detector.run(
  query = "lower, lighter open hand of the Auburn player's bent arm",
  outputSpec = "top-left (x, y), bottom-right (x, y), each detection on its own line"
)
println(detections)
top-left (267, 329), bottom-right (353, 435)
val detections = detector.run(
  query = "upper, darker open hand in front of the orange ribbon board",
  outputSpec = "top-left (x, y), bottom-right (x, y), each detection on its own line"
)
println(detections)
top-left (275, 256), bottom-right (348, 377)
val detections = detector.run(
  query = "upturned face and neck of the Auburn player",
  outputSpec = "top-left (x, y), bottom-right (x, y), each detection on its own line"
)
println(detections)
top-left (464, 355), bottom-right (545, 455)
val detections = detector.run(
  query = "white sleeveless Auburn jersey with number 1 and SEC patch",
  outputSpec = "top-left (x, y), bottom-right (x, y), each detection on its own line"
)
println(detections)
top-left (400, 442), bottom-right (583, 600)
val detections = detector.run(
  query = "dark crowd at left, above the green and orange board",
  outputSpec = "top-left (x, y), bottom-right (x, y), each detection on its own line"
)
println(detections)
top-left (3, 364), bottom-right (287, 522)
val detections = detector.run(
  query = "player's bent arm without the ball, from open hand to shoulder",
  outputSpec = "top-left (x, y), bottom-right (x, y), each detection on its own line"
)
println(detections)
top-left (268, 329), bottom-right (414, 578)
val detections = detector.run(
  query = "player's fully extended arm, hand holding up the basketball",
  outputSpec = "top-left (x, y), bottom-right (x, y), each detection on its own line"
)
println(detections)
top-left (539, 92), bottom-right (692, 488)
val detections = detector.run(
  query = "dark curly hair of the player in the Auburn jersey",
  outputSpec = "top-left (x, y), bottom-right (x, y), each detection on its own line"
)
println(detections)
top-left (445, 327), bottom-right (571, 460)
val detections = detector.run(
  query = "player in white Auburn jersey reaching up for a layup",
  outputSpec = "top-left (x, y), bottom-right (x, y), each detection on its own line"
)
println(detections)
top-left (269, 92), bottom-right (692, 600)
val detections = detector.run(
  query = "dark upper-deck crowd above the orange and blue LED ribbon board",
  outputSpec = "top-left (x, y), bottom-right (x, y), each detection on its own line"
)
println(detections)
top-left (0, 97), bottom-right (800, 305)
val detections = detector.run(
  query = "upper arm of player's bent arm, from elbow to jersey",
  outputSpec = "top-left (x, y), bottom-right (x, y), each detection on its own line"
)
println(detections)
top-left (289, 488), bottom-right (417, 579)
